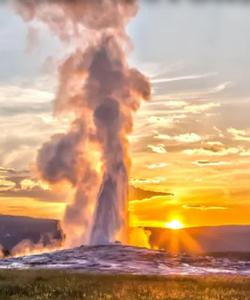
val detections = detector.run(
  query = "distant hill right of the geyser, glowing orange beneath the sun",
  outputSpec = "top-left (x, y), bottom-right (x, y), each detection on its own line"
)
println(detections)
top-left (149, 225), bottom-right (250, 253)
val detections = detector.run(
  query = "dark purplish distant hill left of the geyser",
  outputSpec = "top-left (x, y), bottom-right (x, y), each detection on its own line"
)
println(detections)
top-left (0, 215), bottom-right (63, 251)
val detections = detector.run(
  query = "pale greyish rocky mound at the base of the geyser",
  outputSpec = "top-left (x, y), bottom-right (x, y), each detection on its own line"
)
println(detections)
top-left (0, 244), bottom-right (250, 275)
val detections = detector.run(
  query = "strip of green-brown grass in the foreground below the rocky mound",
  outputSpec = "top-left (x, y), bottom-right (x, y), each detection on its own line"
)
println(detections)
top-left (0, 270), bottom-right (250, 300)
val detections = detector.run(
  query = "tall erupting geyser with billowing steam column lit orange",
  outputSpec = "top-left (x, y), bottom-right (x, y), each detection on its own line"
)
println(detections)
top-left (14, 0), bottom-right (150, 245)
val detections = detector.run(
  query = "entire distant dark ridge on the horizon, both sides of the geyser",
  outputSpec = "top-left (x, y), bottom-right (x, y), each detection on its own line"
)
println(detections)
top-left (0, 215), bottom-right (250, 253)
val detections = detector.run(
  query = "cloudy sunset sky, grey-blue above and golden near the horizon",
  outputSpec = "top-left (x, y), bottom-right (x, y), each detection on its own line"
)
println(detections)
top-left (0, 1), bottom-right (250, 227)
